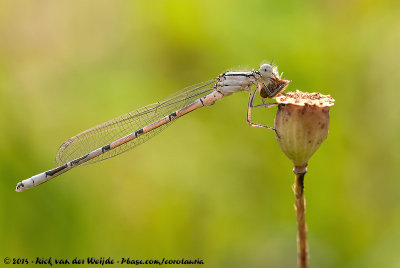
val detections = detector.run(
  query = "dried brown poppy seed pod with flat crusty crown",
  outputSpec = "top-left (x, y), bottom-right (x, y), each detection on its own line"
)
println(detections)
top-left (275, 91), bottom-right (335, 170)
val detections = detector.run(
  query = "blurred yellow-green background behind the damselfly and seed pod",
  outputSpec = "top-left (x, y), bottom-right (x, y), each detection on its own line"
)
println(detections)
top-left (0, 0), bottom-right (400, 267)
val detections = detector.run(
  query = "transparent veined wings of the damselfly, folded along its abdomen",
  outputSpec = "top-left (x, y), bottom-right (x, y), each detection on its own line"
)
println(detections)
top-left (56, 79), bottom-right (216, 165)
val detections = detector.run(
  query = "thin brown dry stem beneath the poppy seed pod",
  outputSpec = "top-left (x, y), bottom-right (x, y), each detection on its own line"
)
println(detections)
top-left (293, 167), bottom-right (308, 268)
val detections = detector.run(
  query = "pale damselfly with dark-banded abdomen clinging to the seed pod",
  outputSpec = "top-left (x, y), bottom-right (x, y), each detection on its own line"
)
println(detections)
top-left (16, 64), bottom-right (290, 192)
